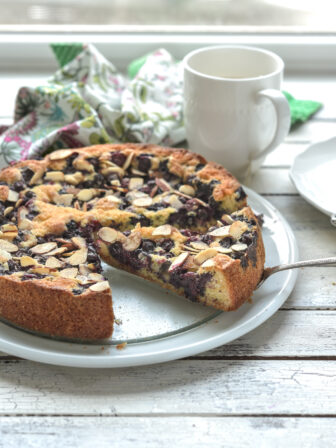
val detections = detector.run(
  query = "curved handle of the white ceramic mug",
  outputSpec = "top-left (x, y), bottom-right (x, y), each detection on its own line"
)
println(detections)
top-left (252, 89), bottom-right (291, 160)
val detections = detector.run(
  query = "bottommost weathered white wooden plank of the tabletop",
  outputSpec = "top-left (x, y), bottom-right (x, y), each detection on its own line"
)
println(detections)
top-left (0, 417), bottom-right (335, 448)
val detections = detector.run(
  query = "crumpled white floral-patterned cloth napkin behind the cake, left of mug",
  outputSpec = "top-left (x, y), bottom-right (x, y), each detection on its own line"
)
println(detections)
top-left (0, 45), bottom-right (185, 162)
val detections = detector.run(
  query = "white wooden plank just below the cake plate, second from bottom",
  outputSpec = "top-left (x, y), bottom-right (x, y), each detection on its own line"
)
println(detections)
top-left (0, 359), bottom-right (336, 416)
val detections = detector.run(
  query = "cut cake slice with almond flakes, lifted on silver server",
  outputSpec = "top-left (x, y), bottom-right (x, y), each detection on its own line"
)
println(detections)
top-left (97, 207), bottom-right (265, 311)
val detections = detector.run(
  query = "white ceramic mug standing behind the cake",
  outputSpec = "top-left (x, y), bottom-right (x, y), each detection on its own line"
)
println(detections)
top-left (183, 46), bottom-right (290, 180)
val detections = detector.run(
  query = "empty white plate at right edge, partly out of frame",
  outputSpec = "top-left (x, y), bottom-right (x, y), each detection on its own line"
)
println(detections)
top-left (289, 137), bottom-right (336, 225)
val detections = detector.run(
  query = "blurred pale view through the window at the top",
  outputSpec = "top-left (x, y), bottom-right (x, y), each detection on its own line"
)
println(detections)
top-left (0, 0), bottom-right (336, 33)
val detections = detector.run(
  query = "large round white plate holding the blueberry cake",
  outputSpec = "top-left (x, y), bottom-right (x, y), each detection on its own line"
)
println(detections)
top-left (0, 188), bottom-right (298, 368)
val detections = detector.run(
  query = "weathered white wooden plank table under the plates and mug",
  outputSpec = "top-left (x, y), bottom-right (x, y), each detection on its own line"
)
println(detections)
top-left (0, 73), bottom-right (336, 448)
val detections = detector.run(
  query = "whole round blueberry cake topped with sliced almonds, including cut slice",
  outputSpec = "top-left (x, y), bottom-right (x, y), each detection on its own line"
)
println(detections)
top-left (0, 144), bottom-right (265, 340)
